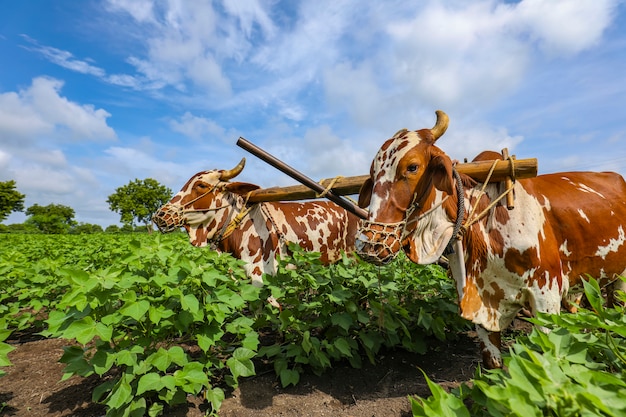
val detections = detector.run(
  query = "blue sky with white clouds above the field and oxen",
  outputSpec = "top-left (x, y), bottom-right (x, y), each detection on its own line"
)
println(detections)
top-left (0, 0), bottom-right (626, 226)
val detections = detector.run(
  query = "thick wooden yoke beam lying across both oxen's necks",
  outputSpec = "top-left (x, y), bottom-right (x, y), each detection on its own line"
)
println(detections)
top-left (249, 158), bottom-right (537, 203)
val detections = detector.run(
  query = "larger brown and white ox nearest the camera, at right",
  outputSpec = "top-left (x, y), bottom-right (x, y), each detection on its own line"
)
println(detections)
top-left (356, 111), bottom-right (626, 368)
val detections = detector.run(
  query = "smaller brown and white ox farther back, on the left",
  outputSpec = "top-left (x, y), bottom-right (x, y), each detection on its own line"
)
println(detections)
top-left (152, 158), bottom-right (359, 286)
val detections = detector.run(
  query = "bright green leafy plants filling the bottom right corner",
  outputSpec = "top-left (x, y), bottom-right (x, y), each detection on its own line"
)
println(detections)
top-left (410, 279), bottom-right (626, 417)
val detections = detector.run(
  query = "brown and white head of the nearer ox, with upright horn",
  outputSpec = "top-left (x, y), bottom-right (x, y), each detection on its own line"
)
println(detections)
top-left (356, 110), bottom-right (454, 264)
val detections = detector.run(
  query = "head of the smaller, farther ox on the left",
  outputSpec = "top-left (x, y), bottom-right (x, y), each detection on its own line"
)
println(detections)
top-left (152, 158), bottom-right (259, 246)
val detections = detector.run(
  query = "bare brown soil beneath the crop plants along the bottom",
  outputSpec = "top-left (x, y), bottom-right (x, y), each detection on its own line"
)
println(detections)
top-left (0, 324), bottom-right (498, 417)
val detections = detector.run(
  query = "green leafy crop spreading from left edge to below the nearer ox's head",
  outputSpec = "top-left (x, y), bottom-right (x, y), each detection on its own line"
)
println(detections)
top-left (0, 234), bottom-right (468, 416)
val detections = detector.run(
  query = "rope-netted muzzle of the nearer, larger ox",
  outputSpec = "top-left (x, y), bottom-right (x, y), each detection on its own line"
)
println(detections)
top-left (355, 220), bottom-right (405, 265)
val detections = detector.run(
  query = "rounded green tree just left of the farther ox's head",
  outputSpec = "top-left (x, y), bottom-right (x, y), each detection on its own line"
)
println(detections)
top-left (107, 178), bottom-right (172, 232)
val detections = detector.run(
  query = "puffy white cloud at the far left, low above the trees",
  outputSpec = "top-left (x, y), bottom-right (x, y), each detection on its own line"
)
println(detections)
top-left (0, 77), bottom-right (117, 222)
